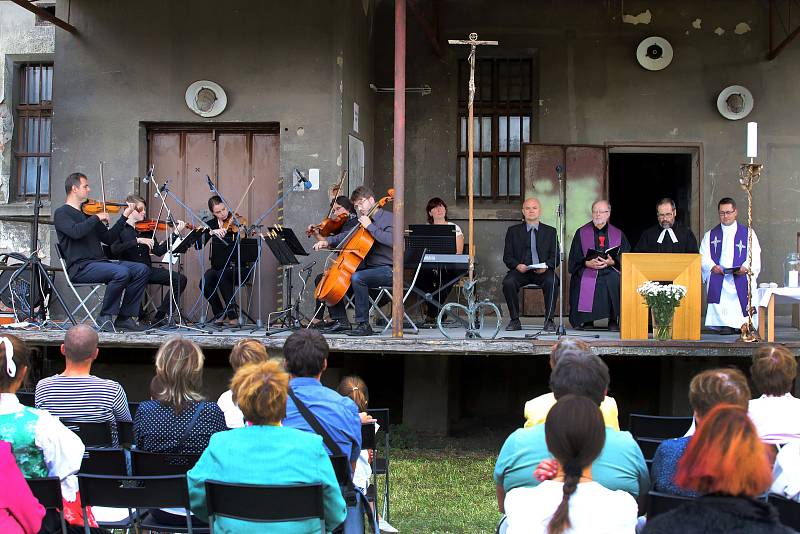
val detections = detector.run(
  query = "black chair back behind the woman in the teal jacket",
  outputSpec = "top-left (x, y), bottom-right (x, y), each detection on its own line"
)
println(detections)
top-left (206, 480), bottom-right (325, 533)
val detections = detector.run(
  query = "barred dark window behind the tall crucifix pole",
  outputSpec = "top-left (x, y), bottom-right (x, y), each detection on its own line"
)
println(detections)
top-left (457, 58), bottom-right (535, 200)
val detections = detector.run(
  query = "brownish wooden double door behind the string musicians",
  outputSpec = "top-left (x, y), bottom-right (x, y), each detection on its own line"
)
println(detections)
top-left (148, 127), bottom-right (281, 321)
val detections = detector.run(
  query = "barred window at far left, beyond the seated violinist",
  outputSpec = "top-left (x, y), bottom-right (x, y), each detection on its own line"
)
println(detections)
top-left (14, 64), bottom-right (53, 198)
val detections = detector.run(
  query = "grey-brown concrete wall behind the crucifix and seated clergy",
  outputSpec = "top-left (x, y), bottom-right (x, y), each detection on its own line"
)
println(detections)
top-left (375, 0), bottom-right (800, 312)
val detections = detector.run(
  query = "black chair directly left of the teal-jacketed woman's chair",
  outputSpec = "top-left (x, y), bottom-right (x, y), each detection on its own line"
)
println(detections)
top-left (78, 473), bottom-right (199, 534)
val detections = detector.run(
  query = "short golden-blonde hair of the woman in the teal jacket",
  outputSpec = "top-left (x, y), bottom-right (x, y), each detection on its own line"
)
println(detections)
top-left (231, 360), bottom-right (289, 425)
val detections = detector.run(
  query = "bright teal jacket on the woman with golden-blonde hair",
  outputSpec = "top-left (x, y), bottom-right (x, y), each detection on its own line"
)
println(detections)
top-left (191, 425), bottom-right (347, 534)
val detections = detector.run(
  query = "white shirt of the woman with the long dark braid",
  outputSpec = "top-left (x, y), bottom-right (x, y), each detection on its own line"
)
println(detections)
top-left (505, 480), bottom-right (638, 534)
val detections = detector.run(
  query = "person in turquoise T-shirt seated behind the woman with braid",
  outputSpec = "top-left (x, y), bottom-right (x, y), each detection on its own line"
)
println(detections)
top-left (494, 352), bottom-right (650, 512)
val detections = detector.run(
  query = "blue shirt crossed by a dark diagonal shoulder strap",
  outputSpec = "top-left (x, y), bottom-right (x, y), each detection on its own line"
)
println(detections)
top-left (283, 377), bottom-right (361, 462)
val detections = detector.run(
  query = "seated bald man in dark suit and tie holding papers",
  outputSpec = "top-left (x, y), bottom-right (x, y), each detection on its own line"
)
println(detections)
top-left (503, 198), bottom-right (558, 331)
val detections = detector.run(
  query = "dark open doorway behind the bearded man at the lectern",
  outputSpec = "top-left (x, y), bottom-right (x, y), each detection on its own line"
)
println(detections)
top-left (608, 152), bottom-right (692, 247)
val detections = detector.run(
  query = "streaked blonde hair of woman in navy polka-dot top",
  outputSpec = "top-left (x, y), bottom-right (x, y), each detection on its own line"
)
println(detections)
top-left (151, 336), bottom-right (205, 413)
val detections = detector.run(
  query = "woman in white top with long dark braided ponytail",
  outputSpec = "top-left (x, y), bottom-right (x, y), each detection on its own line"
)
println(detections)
top-left (505, 395), bottom-right (637, 534)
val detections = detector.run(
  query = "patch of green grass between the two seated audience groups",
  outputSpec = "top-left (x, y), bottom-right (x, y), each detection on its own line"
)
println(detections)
top-left (379, 428), bottom-right (500, 534)
